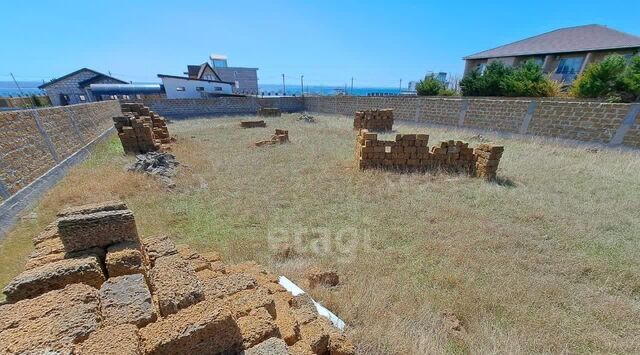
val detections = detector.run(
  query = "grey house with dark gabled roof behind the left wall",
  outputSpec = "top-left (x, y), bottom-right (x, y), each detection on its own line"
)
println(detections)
top-left (38, 68), bottom-right (127, 106)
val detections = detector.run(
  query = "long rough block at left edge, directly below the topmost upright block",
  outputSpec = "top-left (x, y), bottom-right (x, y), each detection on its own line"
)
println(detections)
top-left (3, 256), bottom-right (105, 302)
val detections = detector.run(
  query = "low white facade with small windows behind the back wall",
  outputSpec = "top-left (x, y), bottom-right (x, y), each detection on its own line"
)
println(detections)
top-left (159, 75), bottom-right (233, 99)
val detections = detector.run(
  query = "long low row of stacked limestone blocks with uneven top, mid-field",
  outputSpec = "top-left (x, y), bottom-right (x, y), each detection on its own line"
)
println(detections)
top-left (355, 129), bottom-right (504, 180)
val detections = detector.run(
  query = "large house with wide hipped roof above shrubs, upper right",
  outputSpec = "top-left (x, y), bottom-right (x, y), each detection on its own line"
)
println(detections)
top-left (463, 25), bottom-right (640, 83)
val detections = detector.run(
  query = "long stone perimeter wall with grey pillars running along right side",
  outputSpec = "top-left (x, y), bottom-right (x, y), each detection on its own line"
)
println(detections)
top-left (304, 96), bottom-right (640, 148)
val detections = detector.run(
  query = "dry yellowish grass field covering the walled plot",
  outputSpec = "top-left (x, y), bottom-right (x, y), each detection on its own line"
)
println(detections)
top-left (0, 115), bottom-right (640, 354)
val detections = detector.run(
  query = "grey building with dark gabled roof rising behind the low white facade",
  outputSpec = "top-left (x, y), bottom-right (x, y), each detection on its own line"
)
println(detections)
top-left (184, 54), bottom-right (258, 95)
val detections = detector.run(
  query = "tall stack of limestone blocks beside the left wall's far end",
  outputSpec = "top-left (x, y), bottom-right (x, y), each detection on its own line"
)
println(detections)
top-left (113, 103), bottom-right (171, 154)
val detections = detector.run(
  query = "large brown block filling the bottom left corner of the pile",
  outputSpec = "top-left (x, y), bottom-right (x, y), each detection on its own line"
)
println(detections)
top-left (0, 284), bottom-right (100, 354)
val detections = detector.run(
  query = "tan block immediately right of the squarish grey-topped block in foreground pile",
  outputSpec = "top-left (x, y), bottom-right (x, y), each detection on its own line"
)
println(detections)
top-left (149, 255), bottom-right (204, 317)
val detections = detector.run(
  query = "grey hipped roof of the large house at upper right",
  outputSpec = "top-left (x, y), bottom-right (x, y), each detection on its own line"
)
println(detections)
top-left (463, 25), bottom-right (640, 59)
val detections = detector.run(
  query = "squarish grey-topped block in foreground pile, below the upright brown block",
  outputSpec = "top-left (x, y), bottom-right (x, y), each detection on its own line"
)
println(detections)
top-left (100, 274), bottom-right (156, 327)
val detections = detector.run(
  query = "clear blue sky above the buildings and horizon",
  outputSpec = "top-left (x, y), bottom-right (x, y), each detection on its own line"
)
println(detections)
top-left (0, 0), bottom-right (640, 87)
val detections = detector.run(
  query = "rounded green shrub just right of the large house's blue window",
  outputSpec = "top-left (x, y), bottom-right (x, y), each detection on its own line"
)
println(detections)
top-left (571, 54), bottom-right (630, 102)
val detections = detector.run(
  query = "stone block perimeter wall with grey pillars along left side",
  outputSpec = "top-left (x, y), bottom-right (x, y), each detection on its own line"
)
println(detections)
top-left (0, 101), bottom-right (122, 201)
